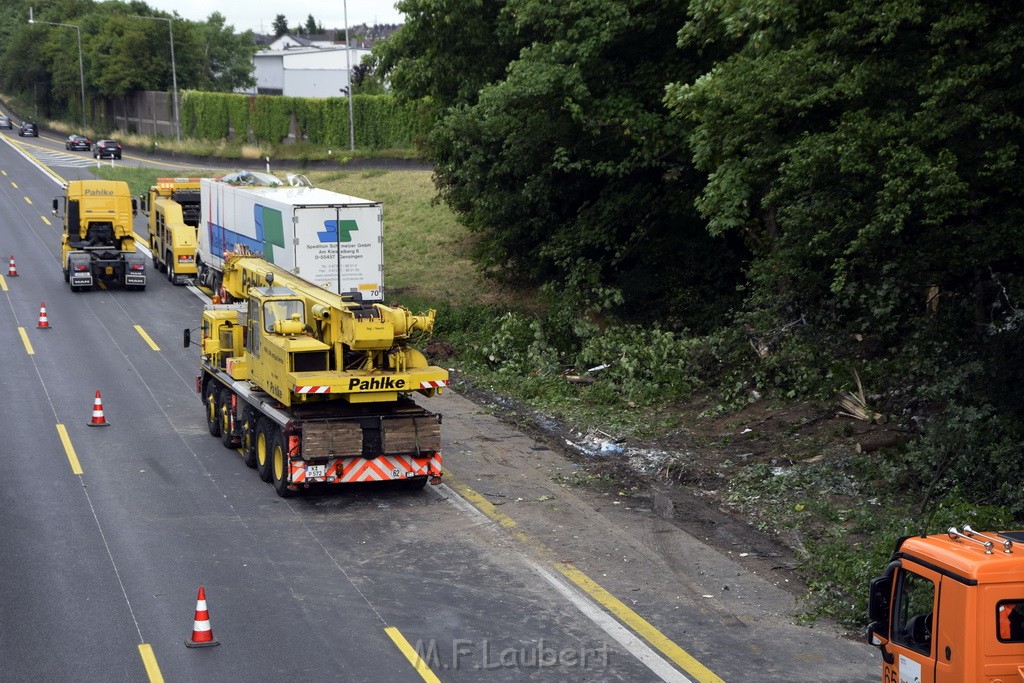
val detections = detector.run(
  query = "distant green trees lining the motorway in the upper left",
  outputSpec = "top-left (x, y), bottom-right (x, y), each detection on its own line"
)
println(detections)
top-left (0, 0), bottom-right (256, 120)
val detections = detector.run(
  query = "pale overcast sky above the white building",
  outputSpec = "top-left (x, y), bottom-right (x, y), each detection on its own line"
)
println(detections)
top-left (146, 0), bottom-right (404, 33)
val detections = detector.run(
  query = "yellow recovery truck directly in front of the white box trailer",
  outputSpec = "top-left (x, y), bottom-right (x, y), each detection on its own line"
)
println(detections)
top-left (139, 178), bottom-right (201, 285)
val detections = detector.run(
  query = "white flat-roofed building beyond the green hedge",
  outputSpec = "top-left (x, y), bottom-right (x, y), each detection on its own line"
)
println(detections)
top-left (253, 34), bottom-right (370, 97)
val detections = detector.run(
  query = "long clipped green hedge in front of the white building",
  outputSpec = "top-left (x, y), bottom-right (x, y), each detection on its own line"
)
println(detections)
top-left (181, 90), bottom-right (433, 150)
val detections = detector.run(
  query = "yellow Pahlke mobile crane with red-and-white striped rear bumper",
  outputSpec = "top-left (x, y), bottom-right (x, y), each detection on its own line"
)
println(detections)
top-left (184, 254), bottom-right (449, 496)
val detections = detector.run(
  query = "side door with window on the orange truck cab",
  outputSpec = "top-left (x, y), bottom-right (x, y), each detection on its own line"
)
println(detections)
top-left (883, 562), bottom-right (941, 683)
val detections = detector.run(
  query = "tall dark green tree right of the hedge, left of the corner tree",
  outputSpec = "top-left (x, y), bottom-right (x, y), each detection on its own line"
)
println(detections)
top-left (381, 0), bottom-right (737, 325)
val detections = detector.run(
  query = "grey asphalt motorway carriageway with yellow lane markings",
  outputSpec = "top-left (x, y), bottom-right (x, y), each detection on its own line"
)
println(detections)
top-left (0, 118), bottom-right (877, 682)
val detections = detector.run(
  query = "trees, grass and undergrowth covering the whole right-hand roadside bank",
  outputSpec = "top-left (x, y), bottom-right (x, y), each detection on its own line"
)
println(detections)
top-left (74, 0), bottom-right (1024, 627)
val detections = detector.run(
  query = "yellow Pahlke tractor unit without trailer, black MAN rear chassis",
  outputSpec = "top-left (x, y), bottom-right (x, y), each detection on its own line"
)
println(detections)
top-left (52, 180), bottom-right (145, 292)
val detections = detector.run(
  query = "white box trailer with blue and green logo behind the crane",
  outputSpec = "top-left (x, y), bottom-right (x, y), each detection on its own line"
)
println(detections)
top-left (197, 171), bottom-right (384, 301)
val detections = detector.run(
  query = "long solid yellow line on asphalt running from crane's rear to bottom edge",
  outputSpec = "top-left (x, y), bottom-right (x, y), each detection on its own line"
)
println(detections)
top-left (444, 472), bottom-right (723, 683)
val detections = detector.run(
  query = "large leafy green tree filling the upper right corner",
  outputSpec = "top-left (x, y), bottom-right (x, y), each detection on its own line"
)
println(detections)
top-left (668, 0), bottom-right (1024, 339)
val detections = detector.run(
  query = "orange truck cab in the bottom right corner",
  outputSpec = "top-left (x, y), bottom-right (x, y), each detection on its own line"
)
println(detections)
top-left (867, 526), bottom-right (1024, 683)
